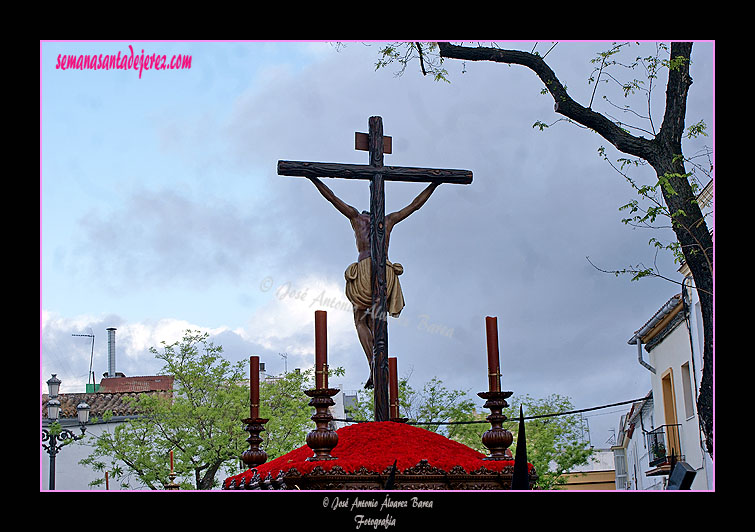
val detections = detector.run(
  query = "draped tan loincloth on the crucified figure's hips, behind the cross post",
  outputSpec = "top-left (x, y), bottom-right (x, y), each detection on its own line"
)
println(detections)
top-left (344, 257), bottom-right (404, 318)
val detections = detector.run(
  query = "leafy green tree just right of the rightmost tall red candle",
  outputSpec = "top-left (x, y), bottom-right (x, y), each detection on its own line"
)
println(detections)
top-left (504, 394), bottom-right (593, 489)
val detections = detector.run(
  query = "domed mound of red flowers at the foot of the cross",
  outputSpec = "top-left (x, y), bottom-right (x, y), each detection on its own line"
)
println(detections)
top-left (225, 421), bottom-right (532, 487)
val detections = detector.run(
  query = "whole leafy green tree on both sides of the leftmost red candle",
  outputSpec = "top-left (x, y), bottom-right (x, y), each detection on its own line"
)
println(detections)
top-left (81, 331), bottom-right (344, 490)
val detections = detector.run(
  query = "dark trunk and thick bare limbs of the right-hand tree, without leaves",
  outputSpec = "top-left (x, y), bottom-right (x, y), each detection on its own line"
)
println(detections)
top-left (438, 43), bottom-right (713, 455)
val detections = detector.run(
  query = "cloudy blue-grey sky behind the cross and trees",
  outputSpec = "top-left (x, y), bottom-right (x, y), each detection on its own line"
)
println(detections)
top-left (40, 41), bottom-right (714, 447)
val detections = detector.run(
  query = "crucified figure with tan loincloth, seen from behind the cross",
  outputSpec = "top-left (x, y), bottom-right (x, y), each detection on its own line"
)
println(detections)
top-left (309, 177), bottom-right (440, 388)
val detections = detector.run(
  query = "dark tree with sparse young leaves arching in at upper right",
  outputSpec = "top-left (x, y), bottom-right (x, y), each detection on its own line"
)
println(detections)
top-left (376, 42), bottom-right (713, 454)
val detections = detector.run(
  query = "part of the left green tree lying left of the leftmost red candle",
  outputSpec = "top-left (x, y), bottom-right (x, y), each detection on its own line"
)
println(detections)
top-left (81, 331), bottom-right (249, 490)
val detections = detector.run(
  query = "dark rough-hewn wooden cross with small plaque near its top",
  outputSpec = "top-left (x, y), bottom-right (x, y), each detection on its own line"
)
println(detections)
top-left (278, 116), bottom-right (472, 421)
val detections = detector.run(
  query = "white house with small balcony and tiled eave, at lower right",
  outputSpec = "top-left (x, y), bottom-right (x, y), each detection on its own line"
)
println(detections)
top-left (615, 290), bottom-right (713, 490)
